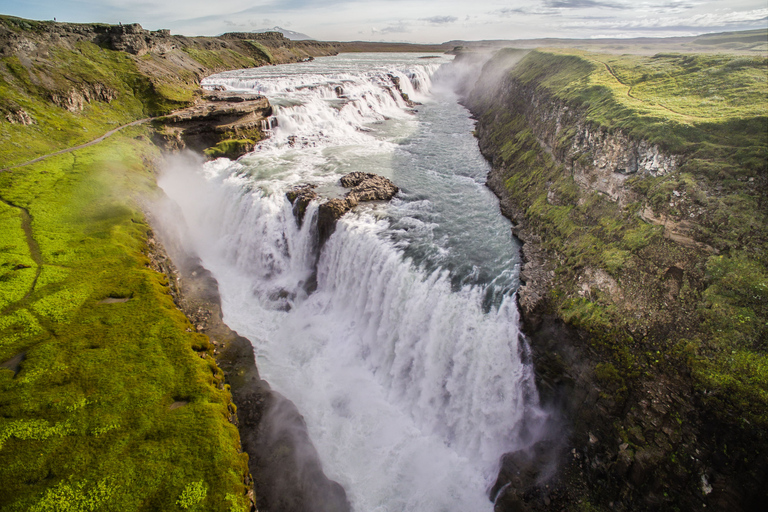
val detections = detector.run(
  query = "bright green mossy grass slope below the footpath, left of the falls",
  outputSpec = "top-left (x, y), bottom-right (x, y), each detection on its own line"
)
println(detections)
top-left (0, 129), bottom-right (247, 511)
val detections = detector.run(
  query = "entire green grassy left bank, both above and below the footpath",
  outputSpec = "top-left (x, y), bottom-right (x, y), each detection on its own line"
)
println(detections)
top-left (0, 17), bottom-right (308, 511)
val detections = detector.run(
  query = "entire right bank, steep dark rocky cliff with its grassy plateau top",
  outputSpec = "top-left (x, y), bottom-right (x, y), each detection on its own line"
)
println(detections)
top-left (459, 50), bottom-right (768, 510)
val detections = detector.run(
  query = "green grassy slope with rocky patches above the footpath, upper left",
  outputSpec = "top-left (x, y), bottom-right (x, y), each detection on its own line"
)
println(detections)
top-left (0, 38), bottom-right (261, 167)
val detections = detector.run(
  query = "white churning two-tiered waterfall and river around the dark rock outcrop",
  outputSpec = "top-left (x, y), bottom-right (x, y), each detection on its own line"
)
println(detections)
top-left (161, 54), bottom-right (542, 512)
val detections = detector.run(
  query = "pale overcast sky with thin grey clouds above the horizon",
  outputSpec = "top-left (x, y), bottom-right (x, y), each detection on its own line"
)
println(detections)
top-left (0, 0), bottom-right (768, 43)
